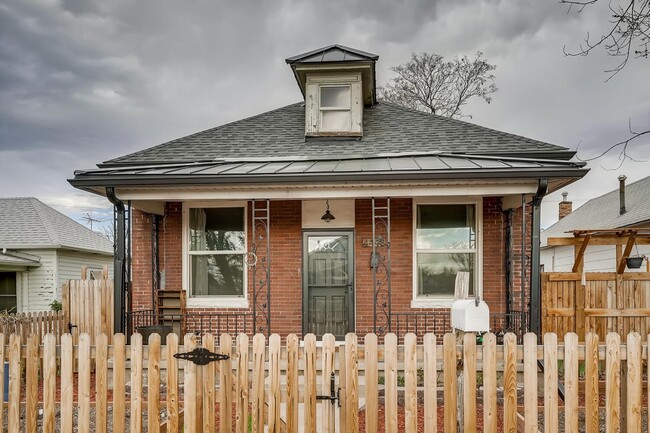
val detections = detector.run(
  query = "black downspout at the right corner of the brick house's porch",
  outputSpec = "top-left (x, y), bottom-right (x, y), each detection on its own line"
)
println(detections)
top-left (530, 179), bottom-right (548, 341)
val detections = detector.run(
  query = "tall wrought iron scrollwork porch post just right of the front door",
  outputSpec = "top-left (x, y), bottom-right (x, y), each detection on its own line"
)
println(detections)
top-left (370, 197), bottom-right (391, 335)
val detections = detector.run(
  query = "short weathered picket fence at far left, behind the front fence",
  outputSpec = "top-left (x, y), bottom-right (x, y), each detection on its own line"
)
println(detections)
top-left (0, 311), bottom-right (68, 344)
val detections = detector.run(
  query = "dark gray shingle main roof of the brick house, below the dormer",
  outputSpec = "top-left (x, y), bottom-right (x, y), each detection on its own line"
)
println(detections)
top-left (101, 102), bottom-right (570, 166)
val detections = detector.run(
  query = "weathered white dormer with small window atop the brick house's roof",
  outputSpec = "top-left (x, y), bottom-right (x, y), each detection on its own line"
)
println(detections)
top-left (286, 45), bottom-right (379, 137)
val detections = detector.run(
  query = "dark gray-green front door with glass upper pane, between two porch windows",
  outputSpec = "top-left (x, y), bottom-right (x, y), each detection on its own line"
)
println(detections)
top-left (303, 231), bottom-right (354, 339)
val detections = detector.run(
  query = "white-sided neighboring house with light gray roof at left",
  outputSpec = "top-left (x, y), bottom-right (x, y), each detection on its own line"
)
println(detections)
top-left (0, 197), bottom-right (113, 312)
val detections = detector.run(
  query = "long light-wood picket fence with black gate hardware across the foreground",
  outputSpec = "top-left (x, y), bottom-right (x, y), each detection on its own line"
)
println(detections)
top-left (0, 333), bottom-right (650, 433)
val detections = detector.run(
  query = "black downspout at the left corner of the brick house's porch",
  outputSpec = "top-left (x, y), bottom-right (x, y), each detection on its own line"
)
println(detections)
top-left (106, 187), bottom-right (126, 333)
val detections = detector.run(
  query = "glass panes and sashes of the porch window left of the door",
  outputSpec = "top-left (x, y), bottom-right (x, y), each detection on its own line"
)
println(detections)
top-left (187, 207), bottom-right (246, 299)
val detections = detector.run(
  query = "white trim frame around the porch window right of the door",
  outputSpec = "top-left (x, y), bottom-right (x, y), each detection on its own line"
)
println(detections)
top-left (411, 197), bottom-right (483, 308)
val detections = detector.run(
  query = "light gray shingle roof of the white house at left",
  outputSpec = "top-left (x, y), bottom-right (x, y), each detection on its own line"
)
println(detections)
top-left (0, 197), bottom-right (113, 255)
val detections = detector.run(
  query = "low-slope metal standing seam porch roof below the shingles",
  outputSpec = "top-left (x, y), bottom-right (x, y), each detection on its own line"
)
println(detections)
top-left (72, 153), bottom-right (585, 186)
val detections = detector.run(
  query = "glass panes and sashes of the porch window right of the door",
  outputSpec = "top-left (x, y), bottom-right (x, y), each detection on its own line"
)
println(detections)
top-left (414, 203), bottom-right (478, 299)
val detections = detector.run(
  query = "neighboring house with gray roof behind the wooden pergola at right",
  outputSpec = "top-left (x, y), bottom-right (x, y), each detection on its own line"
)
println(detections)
top-left (540, 176), bottom-right (650, 272)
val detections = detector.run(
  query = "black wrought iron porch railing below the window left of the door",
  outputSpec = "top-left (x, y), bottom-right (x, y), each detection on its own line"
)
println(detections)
top-left (129, 310), bottom-right (253, 337)
